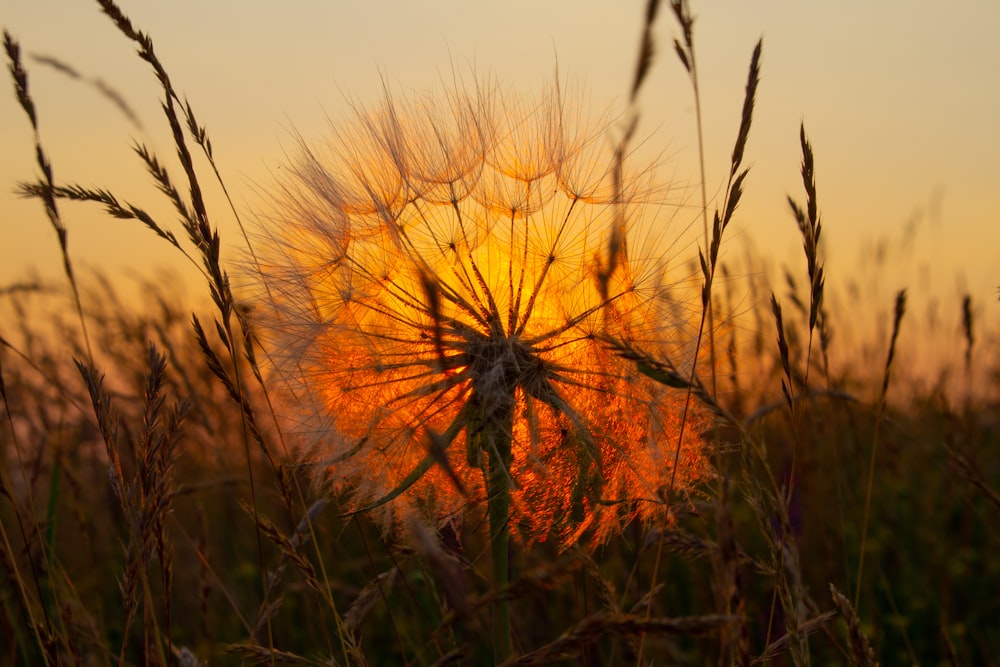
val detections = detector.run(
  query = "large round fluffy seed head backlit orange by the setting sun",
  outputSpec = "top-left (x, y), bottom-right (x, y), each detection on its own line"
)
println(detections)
top-left (250, 75), bottom-right (707, 544)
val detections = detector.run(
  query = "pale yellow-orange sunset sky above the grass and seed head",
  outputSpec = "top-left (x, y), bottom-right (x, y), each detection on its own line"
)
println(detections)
top-left (0, 0), bottom-right (1000, 354)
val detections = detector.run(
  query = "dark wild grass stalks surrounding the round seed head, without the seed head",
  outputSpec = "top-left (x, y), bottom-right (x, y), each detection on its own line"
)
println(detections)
top-left (0, 0), bottom-right (1000, 665)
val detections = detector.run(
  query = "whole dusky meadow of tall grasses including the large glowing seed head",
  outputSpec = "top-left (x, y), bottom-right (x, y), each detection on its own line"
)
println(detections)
top-left (0, 0), bottom-right (1000, 665)
